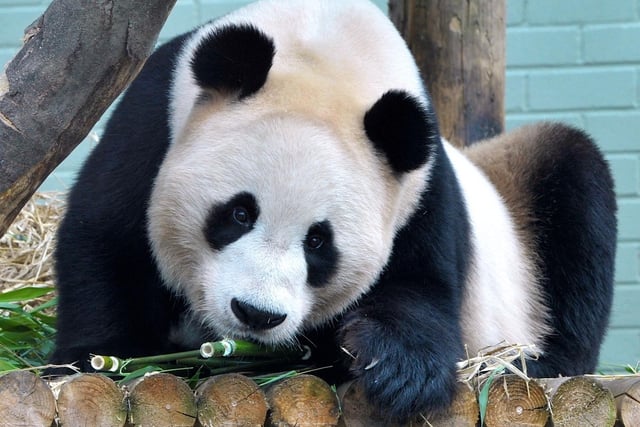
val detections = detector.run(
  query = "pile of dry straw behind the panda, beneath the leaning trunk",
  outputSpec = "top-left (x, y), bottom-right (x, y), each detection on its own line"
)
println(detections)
top-left (0, 193), bottom-right (64, 292)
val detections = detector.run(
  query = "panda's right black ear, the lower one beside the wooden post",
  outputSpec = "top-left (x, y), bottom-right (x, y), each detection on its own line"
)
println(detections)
top-left (364, 90), bottom-right (440, 174)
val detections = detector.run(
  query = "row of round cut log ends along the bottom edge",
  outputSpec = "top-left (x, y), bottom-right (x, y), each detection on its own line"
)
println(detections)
top-left (0, 371), bottom-right (640, 427)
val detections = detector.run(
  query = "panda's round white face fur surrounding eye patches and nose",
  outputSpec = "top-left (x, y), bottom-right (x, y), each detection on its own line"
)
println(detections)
top-left (149, 114), bottom-right (408, 343)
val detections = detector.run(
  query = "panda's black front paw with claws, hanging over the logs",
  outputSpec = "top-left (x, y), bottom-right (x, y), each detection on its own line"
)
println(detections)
top-left (343, 320), bottom-right (456, 422)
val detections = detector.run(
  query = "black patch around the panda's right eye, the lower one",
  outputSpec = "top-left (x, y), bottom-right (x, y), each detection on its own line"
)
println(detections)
top-left (304, 221), bottom-right (339, 287)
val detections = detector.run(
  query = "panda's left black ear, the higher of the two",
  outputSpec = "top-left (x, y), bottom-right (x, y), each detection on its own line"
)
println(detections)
top-left (191, 24), bottom-right (275, 98)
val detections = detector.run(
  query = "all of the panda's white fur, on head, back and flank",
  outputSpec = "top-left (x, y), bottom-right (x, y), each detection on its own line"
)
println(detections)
top-left (149, 0), bottom-right (545, 354)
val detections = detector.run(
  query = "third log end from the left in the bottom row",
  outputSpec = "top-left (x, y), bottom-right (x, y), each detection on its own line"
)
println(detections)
top-left (129, 373), bottom-right (197, 427)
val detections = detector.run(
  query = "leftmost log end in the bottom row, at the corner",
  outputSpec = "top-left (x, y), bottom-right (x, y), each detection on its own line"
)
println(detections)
top-left (0, 371), bottom-right (56, 427)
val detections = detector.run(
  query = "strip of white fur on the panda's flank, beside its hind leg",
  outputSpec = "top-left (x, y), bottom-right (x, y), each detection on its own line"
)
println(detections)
top-left (445, 144), bottom-right (549, 354)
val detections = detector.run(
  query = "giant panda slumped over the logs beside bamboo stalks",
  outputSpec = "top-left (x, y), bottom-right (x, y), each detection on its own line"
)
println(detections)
top-left (51, 0), bottom-right (616, 419)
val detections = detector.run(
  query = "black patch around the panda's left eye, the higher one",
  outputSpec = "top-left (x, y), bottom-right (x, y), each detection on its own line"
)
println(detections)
top-left (203, 192), bottom-right (260, 250)
